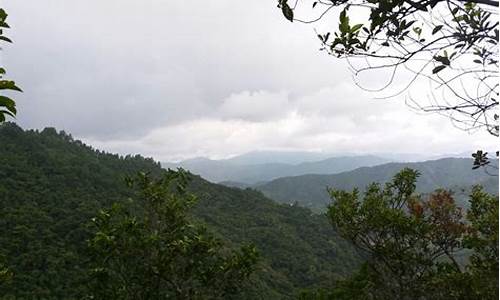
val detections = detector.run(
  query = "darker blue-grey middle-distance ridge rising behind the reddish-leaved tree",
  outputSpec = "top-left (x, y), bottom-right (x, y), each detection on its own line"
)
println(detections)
top-left (253, 158), bottom-right (498, 211)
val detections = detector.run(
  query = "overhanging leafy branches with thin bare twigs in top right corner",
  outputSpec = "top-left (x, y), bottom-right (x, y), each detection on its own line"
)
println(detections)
top-left (278, 0), bottom-right (499, 136)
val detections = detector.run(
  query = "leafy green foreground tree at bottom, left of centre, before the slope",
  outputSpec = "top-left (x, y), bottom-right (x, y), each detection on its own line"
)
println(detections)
top-left (89, 170), bottom-right (257, 299)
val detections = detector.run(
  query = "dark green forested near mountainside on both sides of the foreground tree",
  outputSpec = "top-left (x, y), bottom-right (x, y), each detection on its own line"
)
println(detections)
top-left (0, 123), bottom-right (358, 299)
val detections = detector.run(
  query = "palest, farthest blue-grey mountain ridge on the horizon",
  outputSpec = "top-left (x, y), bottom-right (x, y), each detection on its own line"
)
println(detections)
top-left (162, 154), bottom-right (390, 185)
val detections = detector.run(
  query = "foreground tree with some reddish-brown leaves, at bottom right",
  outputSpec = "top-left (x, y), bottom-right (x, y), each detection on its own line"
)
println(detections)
top-left (310, 169), bottom-right (498, 299)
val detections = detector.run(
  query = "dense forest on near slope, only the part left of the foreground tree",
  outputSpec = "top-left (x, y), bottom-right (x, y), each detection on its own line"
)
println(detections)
top-left (0, 122), bottom-right (160, 299)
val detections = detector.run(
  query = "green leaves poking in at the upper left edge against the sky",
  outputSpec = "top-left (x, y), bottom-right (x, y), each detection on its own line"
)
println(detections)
top-left (0, 8), bottom-right (22, 123)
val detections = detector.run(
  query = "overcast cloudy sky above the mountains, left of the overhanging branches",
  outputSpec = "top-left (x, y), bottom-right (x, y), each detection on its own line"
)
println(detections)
top-left (1, 0), bottom-right (498, 161)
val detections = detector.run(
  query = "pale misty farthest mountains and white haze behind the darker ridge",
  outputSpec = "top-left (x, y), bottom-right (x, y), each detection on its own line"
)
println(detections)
top-left (162, 151), bottom-right (480, 184)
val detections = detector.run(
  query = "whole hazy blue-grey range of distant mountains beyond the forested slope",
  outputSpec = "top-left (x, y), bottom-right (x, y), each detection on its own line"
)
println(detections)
top-left (162, 151), bottom-right (498, 212)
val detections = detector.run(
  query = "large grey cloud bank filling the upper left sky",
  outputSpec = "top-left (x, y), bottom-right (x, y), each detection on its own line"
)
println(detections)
top-left (4, 0), bottom-right (350, 138)
